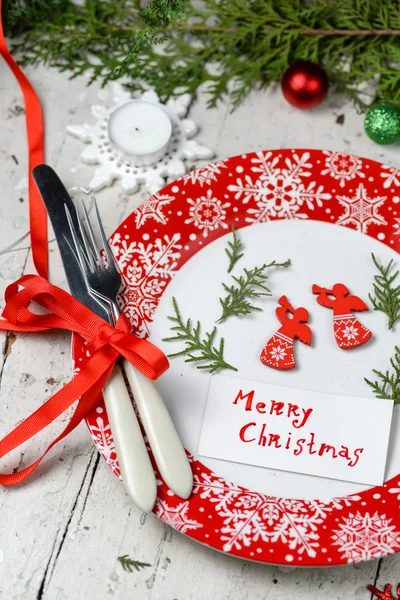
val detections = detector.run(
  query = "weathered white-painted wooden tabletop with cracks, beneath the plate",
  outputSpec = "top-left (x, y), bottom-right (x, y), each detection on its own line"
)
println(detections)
top-left (0, 63), bottom-right (400, 600)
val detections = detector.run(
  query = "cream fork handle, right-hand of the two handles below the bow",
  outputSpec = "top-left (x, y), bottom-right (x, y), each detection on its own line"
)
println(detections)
top-left (122, 360), bottom-right (193, 499)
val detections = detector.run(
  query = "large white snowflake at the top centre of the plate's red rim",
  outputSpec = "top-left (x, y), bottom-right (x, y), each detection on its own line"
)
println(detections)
top-left (228, 152), bottom-right (331, 223)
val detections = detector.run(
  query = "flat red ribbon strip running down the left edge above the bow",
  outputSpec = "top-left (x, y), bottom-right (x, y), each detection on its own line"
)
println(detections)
top-left (0, 0), bottom-right (48, 278)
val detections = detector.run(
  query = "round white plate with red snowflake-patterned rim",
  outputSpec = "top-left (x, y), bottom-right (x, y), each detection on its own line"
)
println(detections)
top-left (74, 150), bottom-right (400, 566)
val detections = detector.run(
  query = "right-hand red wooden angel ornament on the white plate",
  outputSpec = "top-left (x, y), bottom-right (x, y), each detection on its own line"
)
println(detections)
top-left (312, 283), bottom-right (372, 350)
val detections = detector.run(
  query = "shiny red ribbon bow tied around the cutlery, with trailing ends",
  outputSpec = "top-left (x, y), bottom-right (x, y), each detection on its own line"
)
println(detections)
top-left (0, 275), bottom-right (169, 485)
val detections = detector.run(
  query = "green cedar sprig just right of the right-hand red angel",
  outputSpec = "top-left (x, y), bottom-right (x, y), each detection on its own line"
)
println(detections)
top-left (369, 253), bottom-right (400, 329)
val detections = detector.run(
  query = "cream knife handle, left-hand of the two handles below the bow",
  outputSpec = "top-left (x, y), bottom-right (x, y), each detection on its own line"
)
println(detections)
top-left (103, 364), bottom-right (157, 512)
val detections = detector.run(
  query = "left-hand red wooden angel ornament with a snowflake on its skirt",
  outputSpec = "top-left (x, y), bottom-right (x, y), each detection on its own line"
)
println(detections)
top-left (260, 296), bottom-right (312, 369)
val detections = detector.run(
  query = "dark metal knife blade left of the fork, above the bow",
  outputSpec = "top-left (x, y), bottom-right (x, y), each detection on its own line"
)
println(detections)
top-left (32, 165), bottom-right (109, 321)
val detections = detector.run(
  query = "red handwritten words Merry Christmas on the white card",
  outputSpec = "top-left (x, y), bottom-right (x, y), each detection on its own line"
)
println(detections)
top-left (233, 390), bottom-right (364, 467)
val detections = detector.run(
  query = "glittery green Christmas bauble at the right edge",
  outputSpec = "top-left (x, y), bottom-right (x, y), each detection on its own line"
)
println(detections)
top-left (364, 102), bottom-right (400, 144)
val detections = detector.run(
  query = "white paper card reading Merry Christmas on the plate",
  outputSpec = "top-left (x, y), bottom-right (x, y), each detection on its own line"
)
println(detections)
top-left (198, 375), bottom-right (393, 485)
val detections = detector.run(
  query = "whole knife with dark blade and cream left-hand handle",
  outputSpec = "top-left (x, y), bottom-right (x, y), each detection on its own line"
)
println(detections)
top-left (32, 165), bottom-right (157, 512)
